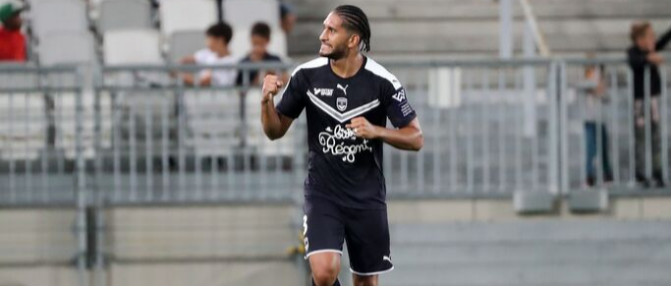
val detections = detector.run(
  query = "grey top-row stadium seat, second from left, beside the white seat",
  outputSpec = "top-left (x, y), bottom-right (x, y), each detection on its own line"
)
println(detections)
top-left (98, 0), bottom-right (151, 33)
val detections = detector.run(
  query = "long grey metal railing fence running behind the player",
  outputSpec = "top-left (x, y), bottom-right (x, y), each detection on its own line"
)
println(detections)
top-left (0, 59), bottom-right (669, 205)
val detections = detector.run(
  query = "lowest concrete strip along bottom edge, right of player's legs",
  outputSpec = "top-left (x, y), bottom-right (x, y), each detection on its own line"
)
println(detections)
top-left (381, 261), bottom-right (671, 286)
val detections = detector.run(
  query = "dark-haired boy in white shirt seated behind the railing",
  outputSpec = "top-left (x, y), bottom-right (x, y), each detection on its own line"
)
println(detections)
top-left (181, 22), bottom-right (237, 86)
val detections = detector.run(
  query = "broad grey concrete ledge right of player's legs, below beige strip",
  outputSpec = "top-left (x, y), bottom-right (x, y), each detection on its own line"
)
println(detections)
top-left (381, 220), bottom-right (671, 286)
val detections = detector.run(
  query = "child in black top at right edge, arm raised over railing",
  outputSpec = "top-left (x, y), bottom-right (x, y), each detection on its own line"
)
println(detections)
top-left (627, 22), bottom-right (671, 187)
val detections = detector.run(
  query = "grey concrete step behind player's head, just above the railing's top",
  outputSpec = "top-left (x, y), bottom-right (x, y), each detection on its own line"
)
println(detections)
top-left (289, 17), bottom-right (669, 54)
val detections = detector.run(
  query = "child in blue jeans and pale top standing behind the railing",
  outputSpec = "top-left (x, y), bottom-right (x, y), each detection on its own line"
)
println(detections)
top-left (580, 58), bottom-right (613, 186)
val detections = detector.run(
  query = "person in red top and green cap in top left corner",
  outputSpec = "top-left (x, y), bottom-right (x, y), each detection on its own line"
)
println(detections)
top-left (0, 2), bottom-right (26, 62)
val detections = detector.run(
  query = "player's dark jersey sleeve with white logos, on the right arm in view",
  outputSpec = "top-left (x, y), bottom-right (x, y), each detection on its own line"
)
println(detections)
top-left (382, 80), bottom-right (417, 128)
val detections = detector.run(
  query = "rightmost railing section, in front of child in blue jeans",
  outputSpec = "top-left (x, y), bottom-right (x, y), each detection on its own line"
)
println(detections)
top-left (560, 59), bottom-right (671, 194)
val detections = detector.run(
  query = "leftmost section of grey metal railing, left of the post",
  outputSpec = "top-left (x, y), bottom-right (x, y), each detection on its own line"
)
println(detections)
top-left (0, 66), bottom-right (85, 205)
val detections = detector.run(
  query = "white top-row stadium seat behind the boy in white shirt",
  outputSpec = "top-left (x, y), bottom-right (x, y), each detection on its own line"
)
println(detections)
top-left (159, 0), bottom-right (217, 37)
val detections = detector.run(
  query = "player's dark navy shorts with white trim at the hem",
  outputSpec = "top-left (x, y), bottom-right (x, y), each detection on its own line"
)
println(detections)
top-left (303, 196), bottom-right (394, 275)
